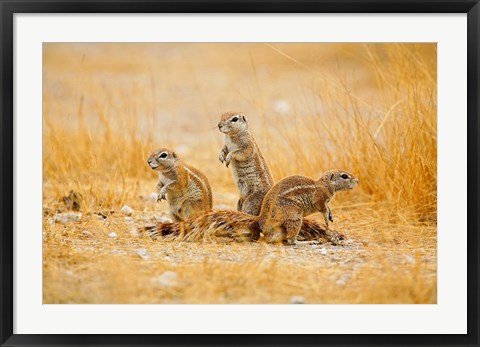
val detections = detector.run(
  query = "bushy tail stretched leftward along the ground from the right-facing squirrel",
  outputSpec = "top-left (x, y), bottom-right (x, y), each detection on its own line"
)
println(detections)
top-left (143, 210), bottom-right (260, 241)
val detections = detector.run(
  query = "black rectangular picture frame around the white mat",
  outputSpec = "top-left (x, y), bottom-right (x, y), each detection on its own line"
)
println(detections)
top-left (0, 0), bottom-right (480, 346)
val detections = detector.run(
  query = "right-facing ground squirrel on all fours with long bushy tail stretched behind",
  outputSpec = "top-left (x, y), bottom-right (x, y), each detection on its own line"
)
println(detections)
top-left (145, 170), bottom-right (358, 244)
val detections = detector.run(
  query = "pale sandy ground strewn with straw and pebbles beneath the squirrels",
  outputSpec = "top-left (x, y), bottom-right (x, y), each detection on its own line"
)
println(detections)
top-left (44, 185), bottom-right (436, 303)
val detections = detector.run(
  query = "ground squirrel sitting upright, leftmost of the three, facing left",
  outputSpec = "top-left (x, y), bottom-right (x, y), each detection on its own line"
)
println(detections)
top-left (147, 148), bottom-right (212, 222)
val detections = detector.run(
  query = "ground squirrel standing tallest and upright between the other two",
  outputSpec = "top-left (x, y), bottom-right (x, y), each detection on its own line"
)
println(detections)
top-left (218, 112), bottom-right (273, 216)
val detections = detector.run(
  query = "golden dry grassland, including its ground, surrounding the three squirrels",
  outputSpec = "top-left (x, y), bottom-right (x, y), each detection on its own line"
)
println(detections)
top-left (43, 44), bottom-right (437, 303)
